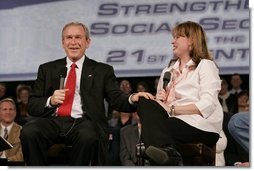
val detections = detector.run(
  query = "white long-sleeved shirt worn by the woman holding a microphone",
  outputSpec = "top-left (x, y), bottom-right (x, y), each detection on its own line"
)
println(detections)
top-left (157, 59), bottom-right (223, 134)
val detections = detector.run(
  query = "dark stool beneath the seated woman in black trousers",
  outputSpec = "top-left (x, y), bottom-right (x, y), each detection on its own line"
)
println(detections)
top-left (176, 143), bottom-right (216, 166)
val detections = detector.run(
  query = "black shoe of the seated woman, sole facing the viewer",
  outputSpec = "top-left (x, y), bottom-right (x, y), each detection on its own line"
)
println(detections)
top-left (145, 146), bottom-right (183, 166)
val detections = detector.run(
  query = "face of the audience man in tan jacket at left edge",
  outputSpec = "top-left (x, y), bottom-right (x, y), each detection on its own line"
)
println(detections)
top-left (0, 101), bottom-right (16, 124)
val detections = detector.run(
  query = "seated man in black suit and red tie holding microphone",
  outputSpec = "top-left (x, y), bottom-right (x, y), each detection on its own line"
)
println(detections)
top-left (21, 22), bottom-right (153, 166)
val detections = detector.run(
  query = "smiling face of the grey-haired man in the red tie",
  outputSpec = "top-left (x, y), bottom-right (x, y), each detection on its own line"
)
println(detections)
top-left (62, 26), bottom-right (90, 62)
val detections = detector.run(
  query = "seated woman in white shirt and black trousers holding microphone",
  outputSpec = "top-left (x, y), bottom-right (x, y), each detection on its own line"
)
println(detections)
top-left (137, 21), bottom-right (223, 165)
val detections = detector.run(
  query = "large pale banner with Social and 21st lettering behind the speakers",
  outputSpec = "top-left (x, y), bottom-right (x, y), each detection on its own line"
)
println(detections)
top-left (0, 0), bottom-right (250, 81)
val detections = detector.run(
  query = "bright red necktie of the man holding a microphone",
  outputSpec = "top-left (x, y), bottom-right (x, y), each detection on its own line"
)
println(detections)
top-left (57, 63), bottom-right (76, 116)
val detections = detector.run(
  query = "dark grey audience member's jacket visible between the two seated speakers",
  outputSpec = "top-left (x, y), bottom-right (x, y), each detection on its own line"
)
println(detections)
top-left (120, 124), bottom-right (139, 166)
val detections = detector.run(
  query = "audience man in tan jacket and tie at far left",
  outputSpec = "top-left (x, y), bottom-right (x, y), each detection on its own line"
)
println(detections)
top-left (0, 98), bottom-right (23, 162)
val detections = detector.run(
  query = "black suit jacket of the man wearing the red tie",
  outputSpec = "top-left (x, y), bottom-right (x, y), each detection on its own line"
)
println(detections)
top-left (29, 57), bottom-right (135, 165)
